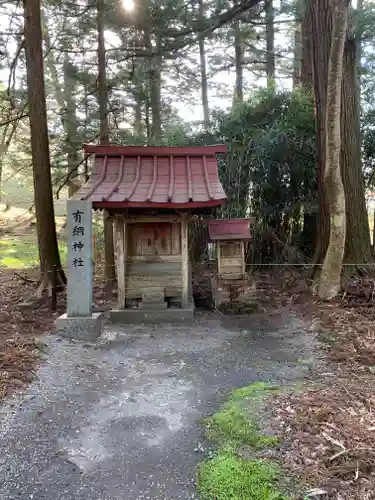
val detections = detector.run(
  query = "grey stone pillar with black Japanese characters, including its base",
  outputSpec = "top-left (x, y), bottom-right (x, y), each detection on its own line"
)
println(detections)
top-left (55, 200), bottom-right (103, 341)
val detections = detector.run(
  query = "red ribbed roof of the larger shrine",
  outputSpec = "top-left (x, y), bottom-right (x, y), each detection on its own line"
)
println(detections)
top-left (73, 145), bottom-right (227, 208)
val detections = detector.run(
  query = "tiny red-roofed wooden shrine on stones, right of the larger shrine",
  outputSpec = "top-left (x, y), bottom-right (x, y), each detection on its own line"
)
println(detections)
top-left (204, 218), bottom-right (255, 309)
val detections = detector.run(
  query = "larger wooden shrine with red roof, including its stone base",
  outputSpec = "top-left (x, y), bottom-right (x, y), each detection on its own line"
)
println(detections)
top-left (73, 145), bottom-right (226, 322)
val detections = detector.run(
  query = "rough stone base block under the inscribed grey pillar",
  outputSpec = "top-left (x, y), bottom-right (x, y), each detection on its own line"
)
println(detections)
top-left (55, 312), bottom-right (104, 342)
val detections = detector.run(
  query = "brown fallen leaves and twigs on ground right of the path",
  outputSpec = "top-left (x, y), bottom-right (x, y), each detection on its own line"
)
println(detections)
top-left (263, 270), bottom-right (375, 500)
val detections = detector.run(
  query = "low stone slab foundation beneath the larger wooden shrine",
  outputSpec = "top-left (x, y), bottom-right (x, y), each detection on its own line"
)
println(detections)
top-left (110, 302), bottom-right (195, 325)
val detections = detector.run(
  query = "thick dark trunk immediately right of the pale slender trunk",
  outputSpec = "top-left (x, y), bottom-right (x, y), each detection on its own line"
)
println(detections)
top-left (340, 39), bottom-right (373, 271)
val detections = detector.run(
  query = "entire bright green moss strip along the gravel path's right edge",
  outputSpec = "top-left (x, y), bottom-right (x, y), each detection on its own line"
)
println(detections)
top-left (198, 382), bottom-right (287, 500)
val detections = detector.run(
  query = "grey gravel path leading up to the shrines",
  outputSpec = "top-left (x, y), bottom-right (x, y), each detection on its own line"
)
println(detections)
top-left (0, 314), bottom-right (311, 500)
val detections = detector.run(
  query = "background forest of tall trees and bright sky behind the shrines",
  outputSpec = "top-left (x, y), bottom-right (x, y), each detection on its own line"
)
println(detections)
top-left (0, 0), bottom-right (375, 298)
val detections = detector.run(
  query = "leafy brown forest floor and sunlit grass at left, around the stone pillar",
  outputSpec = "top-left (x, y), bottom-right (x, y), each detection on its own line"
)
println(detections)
top-left (0, 207), bottom-right (108, 399)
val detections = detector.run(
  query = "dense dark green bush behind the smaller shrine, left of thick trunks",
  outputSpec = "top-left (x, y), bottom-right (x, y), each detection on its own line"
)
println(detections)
top-left (222, 91), bottom-right (315, 223)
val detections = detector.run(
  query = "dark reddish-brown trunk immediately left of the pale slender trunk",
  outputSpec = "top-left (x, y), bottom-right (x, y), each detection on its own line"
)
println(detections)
top-left (307, 0), bottom-right (332, 278)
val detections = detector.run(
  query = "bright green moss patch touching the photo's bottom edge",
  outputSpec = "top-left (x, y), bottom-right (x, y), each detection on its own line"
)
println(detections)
top-left (198, 451), bottom-right (286, 500)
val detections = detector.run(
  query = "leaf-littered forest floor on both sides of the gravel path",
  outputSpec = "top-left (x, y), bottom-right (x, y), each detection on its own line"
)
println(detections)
top-left (0, 206), bottom-right (375, 500)
